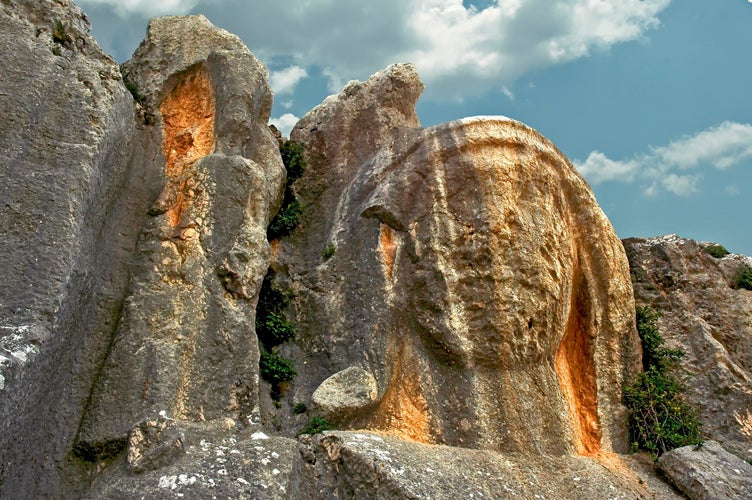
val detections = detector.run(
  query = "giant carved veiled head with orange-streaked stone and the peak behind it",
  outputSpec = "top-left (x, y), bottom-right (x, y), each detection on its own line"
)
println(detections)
top-left (276, 65), bottom-right (639, 455)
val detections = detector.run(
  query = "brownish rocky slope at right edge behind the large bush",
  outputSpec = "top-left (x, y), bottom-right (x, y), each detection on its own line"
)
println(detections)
top-left (624, 235), bottom-right (752, 460)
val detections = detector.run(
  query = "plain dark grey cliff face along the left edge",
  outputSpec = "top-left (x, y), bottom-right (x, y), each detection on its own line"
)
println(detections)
top-left (0, 0), bottom-right (158, 498)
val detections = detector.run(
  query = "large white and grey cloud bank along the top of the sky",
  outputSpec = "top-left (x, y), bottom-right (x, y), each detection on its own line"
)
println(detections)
top-left (80, 0), bottom-right (671, 100)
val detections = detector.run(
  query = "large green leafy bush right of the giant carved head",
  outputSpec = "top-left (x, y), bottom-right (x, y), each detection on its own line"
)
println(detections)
top-left (624, 306), bottom-right (702, 456)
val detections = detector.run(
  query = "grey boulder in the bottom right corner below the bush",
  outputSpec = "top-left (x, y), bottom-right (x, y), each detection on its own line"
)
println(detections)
top-left (658, 441), bottom-right (752, 500)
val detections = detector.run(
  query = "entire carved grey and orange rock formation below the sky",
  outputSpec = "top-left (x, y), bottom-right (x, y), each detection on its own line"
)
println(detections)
top-left (0, 0), bottom-right (750, 498)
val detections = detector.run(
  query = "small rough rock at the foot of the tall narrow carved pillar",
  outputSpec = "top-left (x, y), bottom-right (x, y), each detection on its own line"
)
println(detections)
top-left (126, 415), bottom-right (185, 473)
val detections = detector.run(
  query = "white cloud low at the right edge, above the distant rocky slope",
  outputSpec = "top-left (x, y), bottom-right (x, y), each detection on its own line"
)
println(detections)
top-left (574, 122), bottom-right (752, 196)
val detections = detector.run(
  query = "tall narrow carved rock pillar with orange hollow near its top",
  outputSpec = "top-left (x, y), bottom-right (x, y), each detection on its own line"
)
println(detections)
top-left (78, 16), bottom-right (284, 458)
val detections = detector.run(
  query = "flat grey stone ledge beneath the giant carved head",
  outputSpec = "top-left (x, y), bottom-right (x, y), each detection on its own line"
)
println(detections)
top-left (291, 432), bottom-right (680, 500)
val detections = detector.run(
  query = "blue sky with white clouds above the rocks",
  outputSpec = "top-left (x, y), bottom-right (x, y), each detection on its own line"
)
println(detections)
top-left (77, 0), bottom-right (752, 255)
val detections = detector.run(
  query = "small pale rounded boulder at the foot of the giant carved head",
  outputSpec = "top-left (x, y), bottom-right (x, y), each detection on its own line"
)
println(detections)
top-left (311, 366), bottom-right (378, 424)
